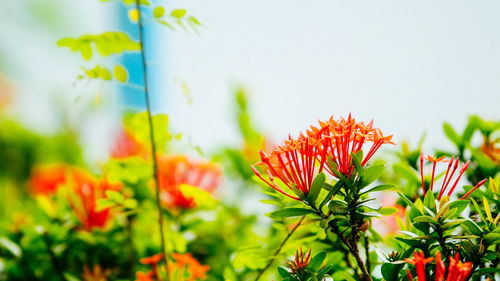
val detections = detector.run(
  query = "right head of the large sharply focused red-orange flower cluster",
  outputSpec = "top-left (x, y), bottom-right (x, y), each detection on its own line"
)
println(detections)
top-left (308, 114), bottom-right (394, 177)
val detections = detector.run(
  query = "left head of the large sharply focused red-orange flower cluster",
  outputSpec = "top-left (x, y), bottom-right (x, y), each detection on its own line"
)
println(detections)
top-left (252, 134), bottom-right (324, 200)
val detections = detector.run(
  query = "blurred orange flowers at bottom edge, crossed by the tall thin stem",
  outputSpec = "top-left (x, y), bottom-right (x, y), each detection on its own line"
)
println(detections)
top-left (136, 253), bottom-right (210, 281)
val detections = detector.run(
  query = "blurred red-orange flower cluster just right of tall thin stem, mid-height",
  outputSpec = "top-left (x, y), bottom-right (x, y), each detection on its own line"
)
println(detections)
top-left (158, 155), bottom-right (221, 209)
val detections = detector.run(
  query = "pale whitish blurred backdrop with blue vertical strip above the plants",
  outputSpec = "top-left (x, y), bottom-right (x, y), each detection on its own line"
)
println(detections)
top-left (0, 0), bottom-right (500, 162)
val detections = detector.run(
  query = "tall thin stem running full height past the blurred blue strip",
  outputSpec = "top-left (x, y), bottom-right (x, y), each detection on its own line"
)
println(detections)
top-left (135, 0), bottom-right (170, 281)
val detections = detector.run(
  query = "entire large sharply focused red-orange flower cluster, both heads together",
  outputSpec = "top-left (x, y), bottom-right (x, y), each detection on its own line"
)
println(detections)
top-left (252, 114), bottom-right (394, 200)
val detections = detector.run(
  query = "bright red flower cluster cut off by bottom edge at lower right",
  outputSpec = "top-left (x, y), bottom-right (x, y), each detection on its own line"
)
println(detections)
top-left (405, 252), bottom-right (472, 281)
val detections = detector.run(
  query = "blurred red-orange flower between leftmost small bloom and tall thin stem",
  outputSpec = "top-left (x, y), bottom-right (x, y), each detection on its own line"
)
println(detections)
top-left (66, 168), bottom-right (121, 231)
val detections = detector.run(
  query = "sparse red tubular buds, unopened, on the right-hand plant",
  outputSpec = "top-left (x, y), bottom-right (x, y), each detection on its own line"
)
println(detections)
top-left (420, 153), bottom-right (487, 200)
